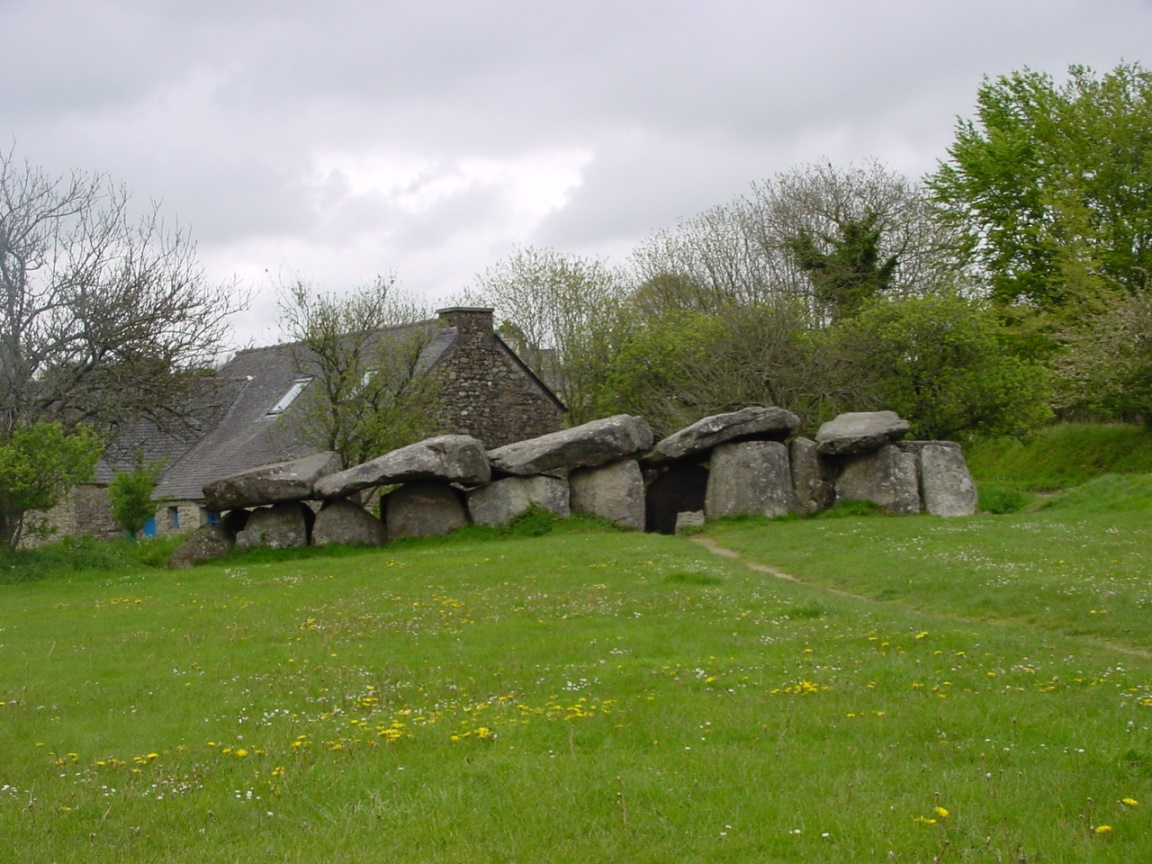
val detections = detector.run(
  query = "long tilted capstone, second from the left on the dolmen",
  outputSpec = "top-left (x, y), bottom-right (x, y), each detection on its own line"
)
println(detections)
top-left (316, 435), bottom-right (492, 499)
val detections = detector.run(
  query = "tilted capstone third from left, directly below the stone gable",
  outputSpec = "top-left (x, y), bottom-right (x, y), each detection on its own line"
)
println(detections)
top-left (488, 414), bottom-right (652, 476)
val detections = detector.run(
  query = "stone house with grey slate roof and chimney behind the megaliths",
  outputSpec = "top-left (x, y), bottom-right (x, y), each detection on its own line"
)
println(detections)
top-left (42, 306), bottom-right (564, 537)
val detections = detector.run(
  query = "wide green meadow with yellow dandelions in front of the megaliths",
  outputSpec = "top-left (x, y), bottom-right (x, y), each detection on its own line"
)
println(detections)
top-left (0, 497), bottom-right (1152, 864)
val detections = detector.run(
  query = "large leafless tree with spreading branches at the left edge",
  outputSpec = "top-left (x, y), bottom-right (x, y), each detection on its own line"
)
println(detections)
top-left (0, 151), bottom-right (245, 439)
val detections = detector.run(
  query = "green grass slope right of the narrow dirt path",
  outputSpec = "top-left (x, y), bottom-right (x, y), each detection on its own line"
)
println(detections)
top-left (707, 475), bottom-right (1152, 652)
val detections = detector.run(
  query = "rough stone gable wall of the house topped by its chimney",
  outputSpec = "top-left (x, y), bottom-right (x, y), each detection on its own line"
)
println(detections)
top-left (435, 308), bottom-right (563, 448)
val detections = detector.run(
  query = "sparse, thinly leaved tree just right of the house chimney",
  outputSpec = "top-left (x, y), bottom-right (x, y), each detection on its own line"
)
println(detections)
top-left (465, 247), bottom-right (629, 424)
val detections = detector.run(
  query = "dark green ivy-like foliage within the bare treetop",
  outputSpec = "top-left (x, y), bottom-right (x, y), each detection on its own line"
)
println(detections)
top-left (788, 213), bottom-right (899, 321)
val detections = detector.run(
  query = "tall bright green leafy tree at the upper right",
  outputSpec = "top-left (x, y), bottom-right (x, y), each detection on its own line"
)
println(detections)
top-left (927, 63), bottom-right (1152, 323)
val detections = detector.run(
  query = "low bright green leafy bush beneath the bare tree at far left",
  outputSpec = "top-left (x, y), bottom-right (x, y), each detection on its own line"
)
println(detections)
top-left (0, 423), bottom-right (104, 550)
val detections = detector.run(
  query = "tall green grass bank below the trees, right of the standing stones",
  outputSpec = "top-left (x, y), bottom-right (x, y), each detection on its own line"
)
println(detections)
top-left (964, 423), bottom-right (1152, 492)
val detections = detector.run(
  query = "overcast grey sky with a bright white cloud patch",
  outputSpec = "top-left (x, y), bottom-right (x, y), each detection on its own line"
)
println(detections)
top-left (0, 0), bottom-right (1152, 343)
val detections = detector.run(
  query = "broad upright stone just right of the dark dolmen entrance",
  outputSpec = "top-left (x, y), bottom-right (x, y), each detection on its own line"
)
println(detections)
top-left (704, 441), bottom-right (794, 520)
